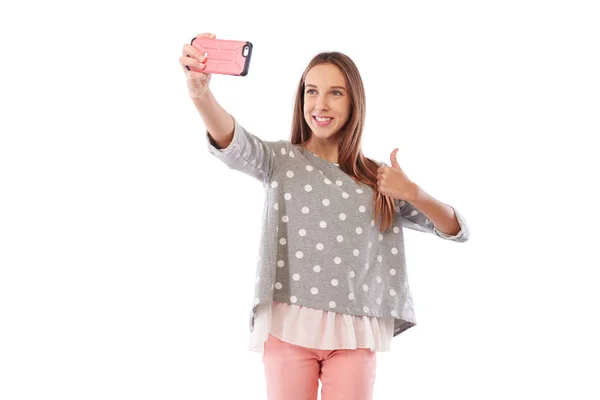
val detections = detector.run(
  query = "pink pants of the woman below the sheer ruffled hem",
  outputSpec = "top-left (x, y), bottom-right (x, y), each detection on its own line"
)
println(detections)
top-left (263, 334), bottom-right (376, 400)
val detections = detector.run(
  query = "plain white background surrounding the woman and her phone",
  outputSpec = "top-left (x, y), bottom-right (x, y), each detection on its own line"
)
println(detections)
top-left (0, 0), bottom-right (600, 400)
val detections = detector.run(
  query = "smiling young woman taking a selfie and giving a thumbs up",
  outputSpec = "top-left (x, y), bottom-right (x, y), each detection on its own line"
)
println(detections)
top-left (180, 33), bottom-right (469, 400)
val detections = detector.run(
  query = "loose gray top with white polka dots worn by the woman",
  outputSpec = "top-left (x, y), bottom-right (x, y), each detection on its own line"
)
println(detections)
top-left (206, 118), bottom-right (469, 336)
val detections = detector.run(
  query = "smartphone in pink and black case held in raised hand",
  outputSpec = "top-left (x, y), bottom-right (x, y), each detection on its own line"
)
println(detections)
top-left (186, 37), bottom-right (252, 76)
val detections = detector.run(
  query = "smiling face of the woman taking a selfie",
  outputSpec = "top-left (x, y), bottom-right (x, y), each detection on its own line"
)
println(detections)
top-left (304, 64), bottom-right (350, 139)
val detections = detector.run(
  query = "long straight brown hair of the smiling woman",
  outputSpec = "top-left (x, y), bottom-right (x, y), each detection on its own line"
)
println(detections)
top-left (290, 52), bottom-right (394, 232)
